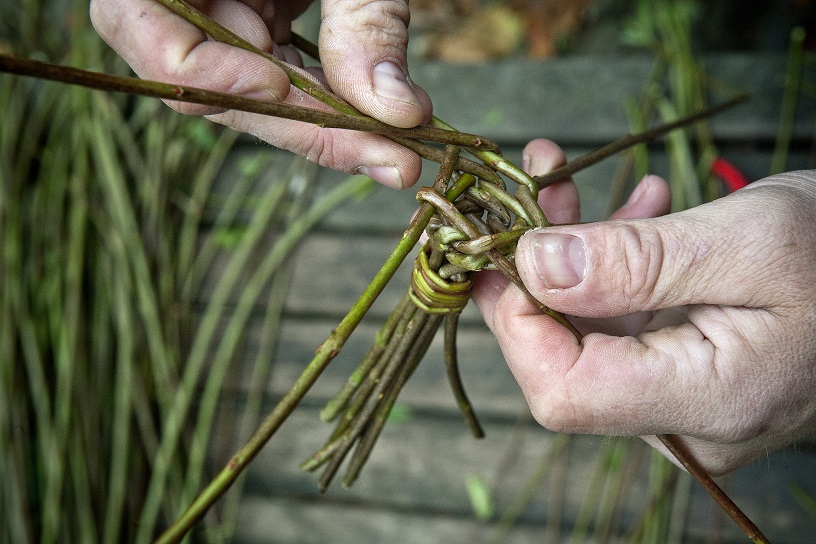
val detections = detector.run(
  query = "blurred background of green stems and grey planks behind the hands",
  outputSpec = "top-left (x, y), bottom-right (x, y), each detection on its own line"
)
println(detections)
top-left (0, 0), bottom-right (816, 544)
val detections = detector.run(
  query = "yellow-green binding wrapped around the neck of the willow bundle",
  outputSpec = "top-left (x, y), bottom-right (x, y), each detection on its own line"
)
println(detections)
top-left (408, 244), bottom-right (472, 315)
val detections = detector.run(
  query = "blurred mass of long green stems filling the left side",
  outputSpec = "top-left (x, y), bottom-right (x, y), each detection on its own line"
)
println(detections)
top-left (0, 0), bottom-right (372, 544)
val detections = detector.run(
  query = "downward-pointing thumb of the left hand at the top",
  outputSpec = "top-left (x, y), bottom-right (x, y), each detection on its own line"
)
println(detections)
top-left (320, 0), bottom-right (431, 127)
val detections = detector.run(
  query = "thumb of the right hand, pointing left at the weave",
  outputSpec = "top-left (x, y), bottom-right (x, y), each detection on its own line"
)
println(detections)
top-left (516, 188), bottom-right (792, 317)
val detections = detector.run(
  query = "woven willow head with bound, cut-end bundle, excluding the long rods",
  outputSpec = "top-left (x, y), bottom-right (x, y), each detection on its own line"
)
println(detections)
top-left (303, 146), bottom-right (579, 491)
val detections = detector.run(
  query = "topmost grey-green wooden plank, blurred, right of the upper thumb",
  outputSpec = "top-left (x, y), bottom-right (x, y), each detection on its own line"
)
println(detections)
top-left (411, 53), bottom-right (816, 145)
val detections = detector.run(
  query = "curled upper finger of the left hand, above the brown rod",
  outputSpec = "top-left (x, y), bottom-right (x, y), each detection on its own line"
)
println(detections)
top-left (91, 0), bottom-right (289, 114)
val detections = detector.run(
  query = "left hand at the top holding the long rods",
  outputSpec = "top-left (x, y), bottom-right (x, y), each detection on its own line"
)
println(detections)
top-left (91, 0), bottom-right (431, 188)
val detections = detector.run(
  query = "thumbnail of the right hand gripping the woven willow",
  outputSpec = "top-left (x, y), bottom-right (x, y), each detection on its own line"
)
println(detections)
top-left (524, 231), bottom-right (586, 289)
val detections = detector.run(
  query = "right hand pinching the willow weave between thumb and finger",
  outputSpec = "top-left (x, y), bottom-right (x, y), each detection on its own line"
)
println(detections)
top-left (474, 138), bottom-right (816, 474)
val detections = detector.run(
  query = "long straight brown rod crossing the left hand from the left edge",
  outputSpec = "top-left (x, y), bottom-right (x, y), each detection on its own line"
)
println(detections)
top-left (0, 54), bottom-right (498, 153)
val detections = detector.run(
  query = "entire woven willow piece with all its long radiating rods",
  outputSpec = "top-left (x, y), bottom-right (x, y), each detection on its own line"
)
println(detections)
top-left (0, 0), bottom-right (769, 543)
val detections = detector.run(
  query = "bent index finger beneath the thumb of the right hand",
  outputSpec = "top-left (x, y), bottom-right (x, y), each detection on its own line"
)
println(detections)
top-left (491, 286), bottom-right (723, 436)
